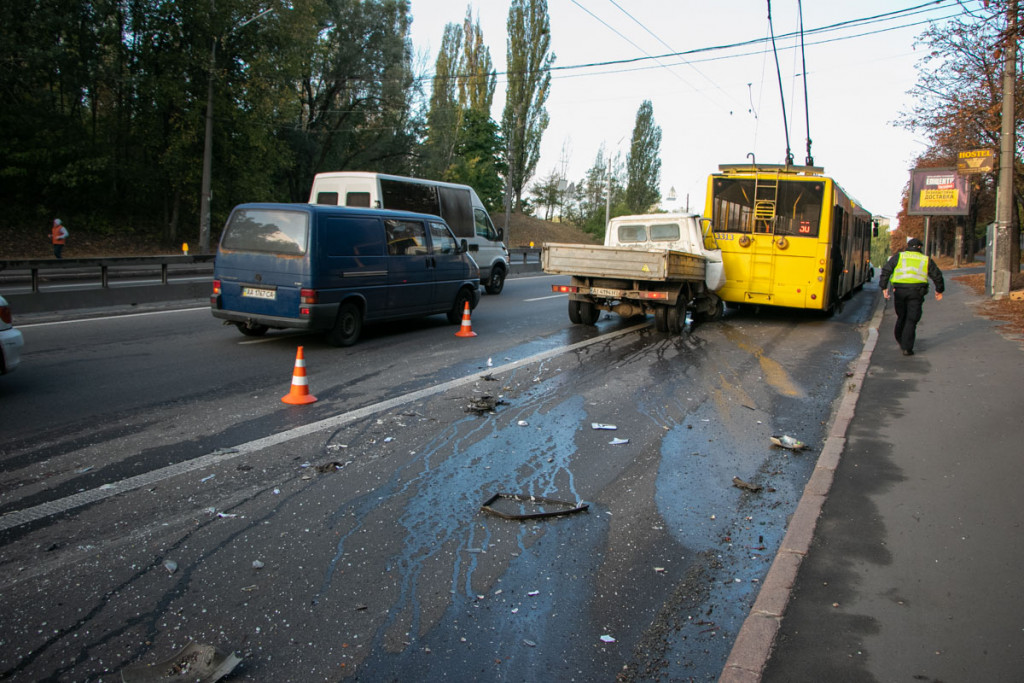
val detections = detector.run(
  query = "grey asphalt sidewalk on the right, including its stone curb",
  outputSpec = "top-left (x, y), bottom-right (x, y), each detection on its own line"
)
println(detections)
top-left (721, 272), bottom-right (1024, 683)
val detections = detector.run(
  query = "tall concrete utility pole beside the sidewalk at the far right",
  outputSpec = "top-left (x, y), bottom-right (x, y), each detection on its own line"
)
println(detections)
top-left (991, 0), bottom-right (1017, 299)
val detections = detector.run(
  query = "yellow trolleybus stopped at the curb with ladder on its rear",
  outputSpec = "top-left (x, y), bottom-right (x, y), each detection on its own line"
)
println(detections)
top-left (706, 164), bottom-right (872, 311)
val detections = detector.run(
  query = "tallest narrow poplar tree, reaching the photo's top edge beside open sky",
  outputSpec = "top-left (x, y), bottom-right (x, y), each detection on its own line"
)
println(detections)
top-left (502, 0), bottom-right (555, 210)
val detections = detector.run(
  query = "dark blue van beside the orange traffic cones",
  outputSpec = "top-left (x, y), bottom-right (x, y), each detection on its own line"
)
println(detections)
top-left (210, 204), bottom-right (480, 346)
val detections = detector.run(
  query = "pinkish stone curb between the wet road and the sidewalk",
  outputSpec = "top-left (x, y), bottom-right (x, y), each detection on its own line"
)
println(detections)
top-left (718, 300), bottom-right (885, 683)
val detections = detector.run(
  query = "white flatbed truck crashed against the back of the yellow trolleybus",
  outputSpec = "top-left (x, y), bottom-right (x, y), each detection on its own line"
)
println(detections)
top-left (541, 213), bottom-right (725, 334)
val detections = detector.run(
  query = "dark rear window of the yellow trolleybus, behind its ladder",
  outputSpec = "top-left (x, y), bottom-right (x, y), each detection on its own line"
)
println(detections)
top-left (712, 177), bottom-right (824, 238)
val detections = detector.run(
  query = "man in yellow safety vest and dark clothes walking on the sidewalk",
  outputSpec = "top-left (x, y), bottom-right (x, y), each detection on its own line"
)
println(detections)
top-left (879, 238), bottom-right (946, 355)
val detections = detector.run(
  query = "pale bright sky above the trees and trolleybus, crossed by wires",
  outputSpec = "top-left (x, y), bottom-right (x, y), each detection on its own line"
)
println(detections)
top-left (410, 0), bottom-right (981, 225)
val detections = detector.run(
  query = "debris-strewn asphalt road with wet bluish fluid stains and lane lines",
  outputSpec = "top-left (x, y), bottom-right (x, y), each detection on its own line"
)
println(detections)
top-left (0, 278), bottom-right (877, 681)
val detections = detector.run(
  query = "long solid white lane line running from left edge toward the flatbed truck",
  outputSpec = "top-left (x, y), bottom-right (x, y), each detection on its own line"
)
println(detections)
top-left (0, 323), bottom-right (650, 531)
